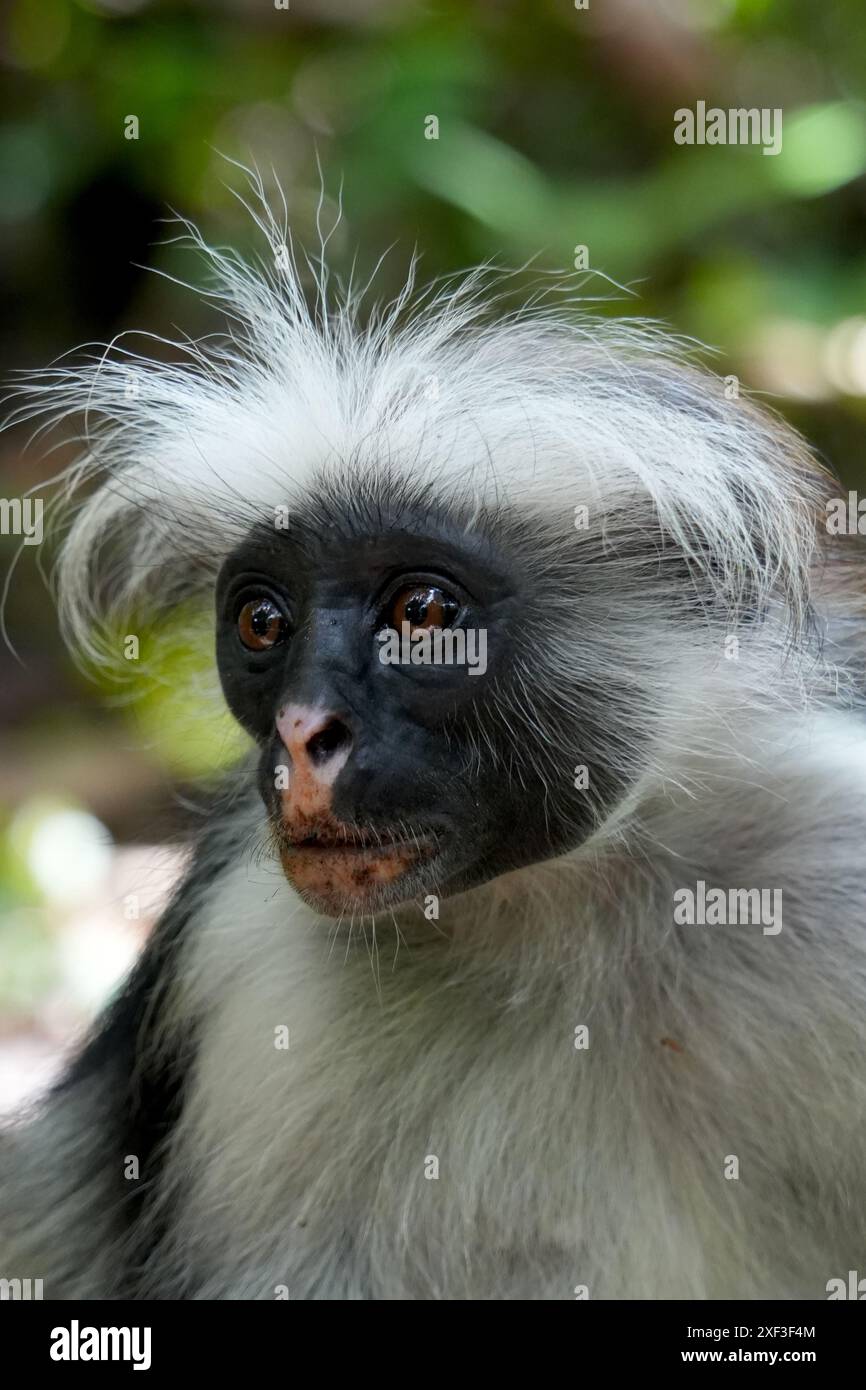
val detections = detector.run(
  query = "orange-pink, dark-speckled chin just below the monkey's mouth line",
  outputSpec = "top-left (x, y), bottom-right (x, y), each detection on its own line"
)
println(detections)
top-left (279, 844), bottom-right (436, 917)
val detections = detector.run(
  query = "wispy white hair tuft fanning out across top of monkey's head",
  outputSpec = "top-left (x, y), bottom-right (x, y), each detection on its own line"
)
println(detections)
top-left (5, 165), bottom-right (826, 675)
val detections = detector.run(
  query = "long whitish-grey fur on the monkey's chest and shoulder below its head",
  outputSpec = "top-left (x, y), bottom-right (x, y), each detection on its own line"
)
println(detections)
top-left (115, 695), bottom-right (866, 1298)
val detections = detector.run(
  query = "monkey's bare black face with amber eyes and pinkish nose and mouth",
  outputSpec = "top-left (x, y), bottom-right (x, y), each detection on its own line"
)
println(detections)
top-left (217, 489), bottom-right (606, 913)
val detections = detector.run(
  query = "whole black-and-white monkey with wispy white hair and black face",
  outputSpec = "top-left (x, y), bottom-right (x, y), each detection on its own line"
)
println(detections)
top-left (0, 195), bottom-right (866, 1301)
